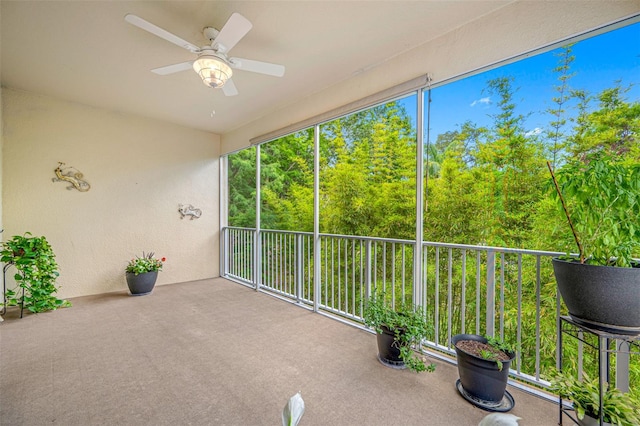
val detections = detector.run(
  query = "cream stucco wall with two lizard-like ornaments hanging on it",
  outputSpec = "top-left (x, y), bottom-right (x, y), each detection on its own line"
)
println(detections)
top-left (2, 88), bottom-right (220, 297)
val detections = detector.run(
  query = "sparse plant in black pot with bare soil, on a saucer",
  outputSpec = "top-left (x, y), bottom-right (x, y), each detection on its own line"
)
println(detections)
top-left (451, 334), bottom-right (515, 411)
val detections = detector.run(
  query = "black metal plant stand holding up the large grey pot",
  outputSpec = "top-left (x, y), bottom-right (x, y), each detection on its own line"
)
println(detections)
top-left (558, 316), bottom-right (640, 425)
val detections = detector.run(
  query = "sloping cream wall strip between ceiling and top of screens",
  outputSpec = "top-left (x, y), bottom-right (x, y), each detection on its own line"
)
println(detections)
top-left (221, 0), bottom-right (640, 154)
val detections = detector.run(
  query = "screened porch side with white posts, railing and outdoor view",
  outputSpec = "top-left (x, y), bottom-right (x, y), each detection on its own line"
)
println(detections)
top-left (221, 18), bottom-right (640, 406)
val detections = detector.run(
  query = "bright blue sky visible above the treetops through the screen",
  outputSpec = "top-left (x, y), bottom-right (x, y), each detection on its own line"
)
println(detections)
top-left (398, 23), bottom-right (640, 142)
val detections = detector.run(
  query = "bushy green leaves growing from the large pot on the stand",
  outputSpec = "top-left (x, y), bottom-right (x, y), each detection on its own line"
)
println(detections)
top-left (549, 152), bottom-right (640, 267)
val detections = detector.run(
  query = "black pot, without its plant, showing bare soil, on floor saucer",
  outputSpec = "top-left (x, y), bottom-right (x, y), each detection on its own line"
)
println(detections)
top-left (451, 334), bottom-right (515, 411)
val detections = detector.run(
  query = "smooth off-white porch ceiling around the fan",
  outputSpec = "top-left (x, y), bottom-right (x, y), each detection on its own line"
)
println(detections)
top-left (0, 0), bottom-right (511, 134)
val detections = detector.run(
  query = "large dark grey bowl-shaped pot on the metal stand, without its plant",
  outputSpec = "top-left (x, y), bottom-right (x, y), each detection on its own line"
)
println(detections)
top-left (553, 259), bottom-right (640, 335)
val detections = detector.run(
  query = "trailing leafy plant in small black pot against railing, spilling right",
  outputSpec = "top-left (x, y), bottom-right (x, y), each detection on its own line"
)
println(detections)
top-left (363, 292), bottom-right (435, 372)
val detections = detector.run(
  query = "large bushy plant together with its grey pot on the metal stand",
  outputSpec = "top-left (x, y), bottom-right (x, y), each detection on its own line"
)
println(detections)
top-left (549, 152), bottom-right (640, 334)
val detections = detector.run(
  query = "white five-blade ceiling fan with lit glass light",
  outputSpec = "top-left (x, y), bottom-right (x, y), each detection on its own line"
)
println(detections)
top-left (124, 13), bottom-right (284, 96)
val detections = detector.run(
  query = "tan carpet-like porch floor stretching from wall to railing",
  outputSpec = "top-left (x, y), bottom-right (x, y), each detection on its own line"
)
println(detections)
top-left (0, 278), bottom-right (570, 426)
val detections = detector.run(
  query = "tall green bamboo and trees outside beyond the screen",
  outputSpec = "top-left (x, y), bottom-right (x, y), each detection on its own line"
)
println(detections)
top-left (229, 34), bottom-right (640, 390)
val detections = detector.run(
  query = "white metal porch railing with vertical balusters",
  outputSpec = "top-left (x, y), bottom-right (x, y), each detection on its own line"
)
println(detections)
top-left (222, 227), bottom-right (628, 396)
